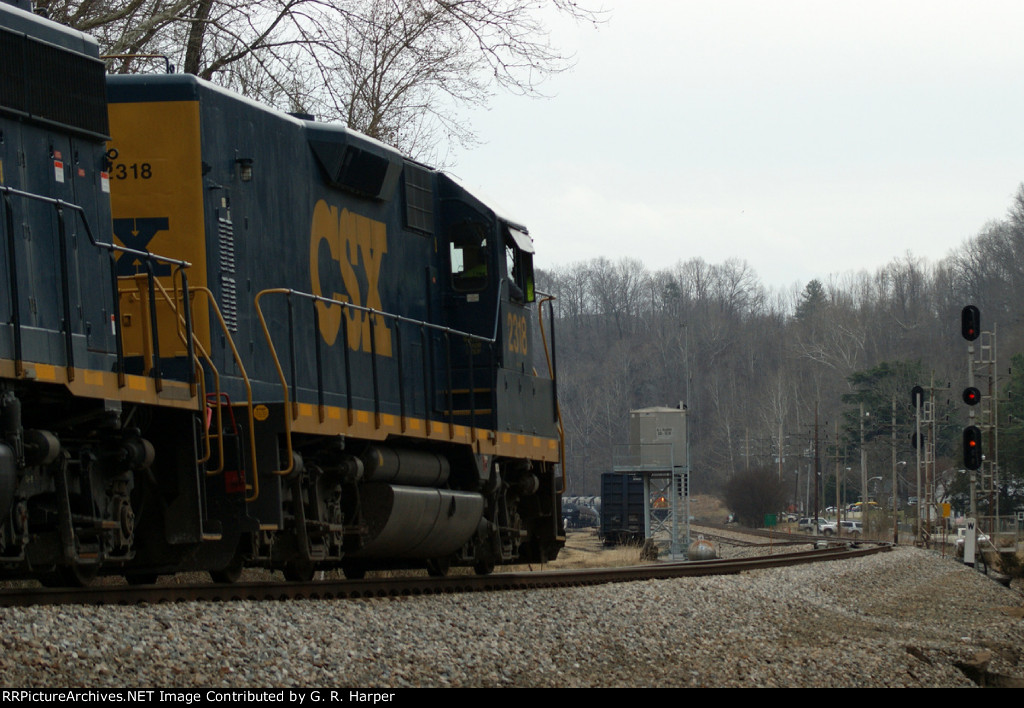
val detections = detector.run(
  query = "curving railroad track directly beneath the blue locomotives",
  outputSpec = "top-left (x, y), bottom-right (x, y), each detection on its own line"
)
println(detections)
top-left (0, 544), bottom-right (891, 607)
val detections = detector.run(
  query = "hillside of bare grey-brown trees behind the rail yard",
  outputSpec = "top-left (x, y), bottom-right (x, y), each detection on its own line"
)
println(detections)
top-left (539, 184), bottom-right (1024, 509)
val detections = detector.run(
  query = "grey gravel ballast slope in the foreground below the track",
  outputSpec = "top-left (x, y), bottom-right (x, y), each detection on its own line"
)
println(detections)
top-left (0, 548), bottom-right (1024, 689)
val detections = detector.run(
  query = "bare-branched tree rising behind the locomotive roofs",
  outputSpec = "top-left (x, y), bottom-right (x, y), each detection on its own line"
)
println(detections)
top-left (44, 0), bottom-right (602, 157)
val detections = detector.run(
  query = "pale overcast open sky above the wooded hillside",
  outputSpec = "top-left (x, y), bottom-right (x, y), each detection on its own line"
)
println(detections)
top-left (452, 0), bottom-right (1024, 288)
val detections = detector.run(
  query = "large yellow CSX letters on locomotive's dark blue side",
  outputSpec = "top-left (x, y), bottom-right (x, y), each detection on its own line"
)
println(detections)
top-left (309, 200), bottom-right (391, 357)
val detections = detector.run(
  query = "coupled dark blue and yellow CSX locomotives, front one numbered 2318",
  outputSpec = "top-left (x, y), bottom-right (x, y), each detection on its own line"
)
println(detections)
top-left (0, 3), bottom-right (563, 584)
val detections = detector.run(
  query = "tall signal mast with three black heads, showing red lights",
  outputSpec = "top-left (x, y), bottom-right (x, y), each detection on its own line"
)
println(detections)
top-left (961, 305), bottom-right (999, 533)
